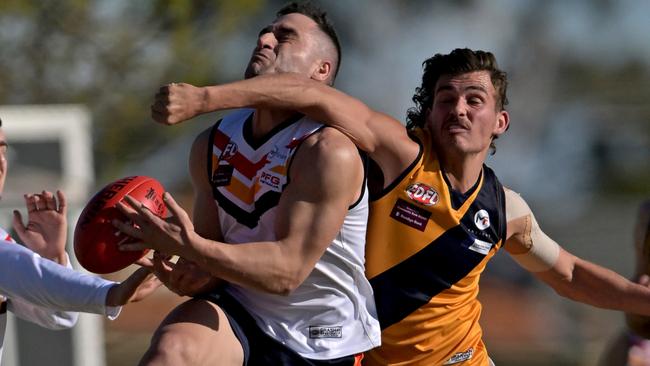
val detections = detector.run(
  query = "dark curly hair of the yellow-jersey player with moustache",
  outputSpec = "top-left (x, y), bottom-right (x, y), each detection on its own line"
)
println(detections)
top-left (406, 48), bottom-right (508, 149)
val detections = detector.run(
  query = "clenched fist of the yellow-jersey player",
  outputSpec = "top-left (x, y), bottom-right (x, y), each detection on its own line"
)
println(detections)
top-left (151, 83), bottom-right (206, 125)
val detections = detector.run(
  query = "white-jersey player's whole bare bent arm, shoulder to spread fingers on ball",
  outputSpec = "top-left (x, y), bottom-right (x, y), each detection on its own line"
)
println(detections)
top-left (115, 129), bottom-right (363, 294)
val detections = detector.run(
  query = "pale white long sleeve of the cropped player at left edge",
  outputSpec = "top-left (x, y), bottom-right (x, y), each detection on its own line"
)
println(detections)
top-left (0, 241), bottom-right (119, 328)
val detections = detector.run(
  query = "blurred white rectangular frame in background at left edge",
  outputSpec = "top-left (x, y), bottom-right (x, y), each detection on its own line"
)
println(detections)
top-left (0, 105), bottom-right (105, 366)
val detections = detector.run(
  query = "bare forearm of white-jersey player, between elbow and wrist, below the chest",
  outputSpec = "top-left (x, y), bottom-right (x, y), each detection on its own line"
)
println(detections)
top-left (186, 237), bottom-right (309, 295)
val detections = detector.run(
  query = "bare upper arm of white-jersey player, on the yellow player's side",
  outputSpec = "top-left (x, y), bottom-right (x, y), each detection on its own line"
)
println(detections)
top-left (276, 132), bottom-right (363, 274)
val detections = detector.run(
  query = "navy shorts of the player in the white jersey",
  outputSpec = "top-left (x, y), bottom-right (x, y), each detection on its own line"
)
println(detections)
top-left (199, 291), bottom-right (363, 366)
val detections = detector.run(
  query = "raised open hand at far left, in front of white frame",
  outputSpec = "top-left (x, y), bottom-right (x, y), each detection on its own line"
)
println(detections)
top-left (13, 191), bottom-right (68, 264)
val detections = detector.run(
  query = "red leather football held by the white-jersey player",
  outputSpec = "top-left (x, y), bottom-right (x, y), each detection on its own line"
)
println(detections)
top-left (74, 176), bottom-right (167, 273)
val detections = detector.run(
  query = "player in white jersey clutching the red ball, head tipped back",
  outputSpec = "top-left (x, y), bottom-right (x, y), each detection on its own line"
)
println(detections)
top-left (116, 3), bottom-right (379, 365)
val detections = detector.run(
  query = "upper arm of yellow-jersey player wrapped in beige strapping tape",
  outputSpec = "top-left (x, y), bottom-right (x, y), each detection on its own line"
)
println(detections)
top-left (504, 188), bottom-right (560, 272)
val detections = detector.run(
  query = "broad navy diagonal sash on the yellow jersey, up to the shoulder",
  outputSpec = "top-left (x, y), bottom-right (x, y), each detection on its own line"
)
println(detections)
top-left (370, 167), bottom-right (506, 329)
